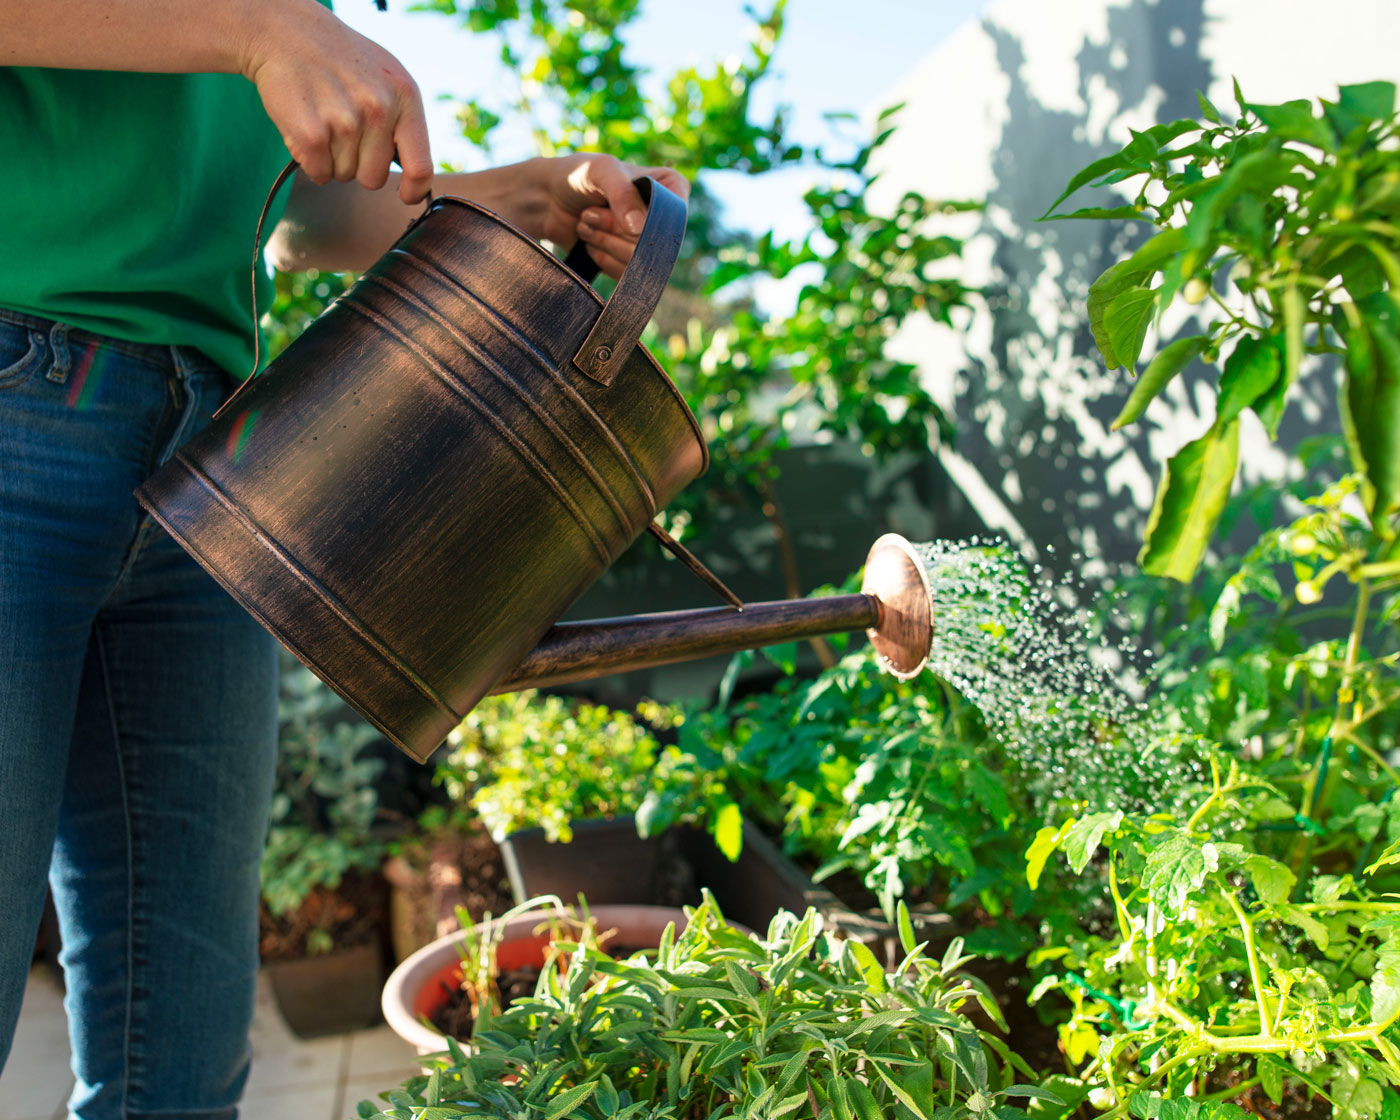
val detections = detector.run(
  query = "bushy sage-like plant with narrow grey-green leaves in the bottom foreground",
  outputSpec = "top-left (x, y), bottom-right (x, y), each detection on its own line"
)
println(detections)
top-left (360, 899), bottom-right (1061, 1120)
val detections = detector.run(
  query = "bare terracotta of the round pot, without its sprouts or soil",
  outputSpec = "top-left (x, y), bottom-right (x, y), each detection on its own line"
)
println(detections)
top-left (381, 906), bottom-right (686, 1054)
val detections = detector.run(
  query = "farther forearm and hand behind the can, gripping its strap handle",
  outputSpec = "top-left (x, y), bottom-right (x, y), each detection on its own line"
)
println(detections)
top-left (267, 153), bottom-right (690, 277)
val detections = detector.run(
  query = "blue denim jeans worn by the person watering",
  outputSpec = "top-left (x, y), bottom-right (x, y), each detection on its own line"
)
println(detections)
top-left (0, 311), bottom-right (277, 1120)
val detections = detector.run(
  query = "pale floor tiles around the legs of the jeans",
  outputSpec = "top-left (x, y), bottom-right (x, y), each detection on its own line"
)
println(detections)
top-left (0, 969), bottom-right (419, 1120)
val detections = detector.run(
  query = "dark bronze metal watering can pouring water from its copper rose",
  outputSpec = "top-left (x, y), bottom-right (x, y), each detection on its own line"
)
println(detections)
top-left (137, 169), bottom-right (932, 762)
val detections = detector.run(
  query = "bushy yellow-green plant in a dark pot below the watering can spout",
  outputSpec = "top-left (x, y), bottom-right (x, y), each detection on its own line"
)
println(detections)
top-left (437, 692), bottom-right (839, 927)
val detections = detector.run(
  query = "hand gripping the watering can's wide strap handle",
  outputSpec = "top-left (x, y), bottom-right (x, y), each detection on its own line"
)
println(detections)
top-left (526, 153), bottom-right (690, 280)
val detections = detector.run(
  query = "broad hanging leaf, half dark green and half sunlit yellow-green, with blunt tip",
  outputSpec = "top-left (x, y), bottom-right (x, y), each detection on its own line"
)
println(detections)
top-left (1138, 420), bottom-right (1239, 582)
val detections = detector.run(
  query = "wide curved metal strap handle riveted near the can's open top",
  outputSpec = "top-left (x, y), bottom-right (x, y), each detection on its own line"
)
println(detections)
top-left (562, 176), bottom-right (686, 385)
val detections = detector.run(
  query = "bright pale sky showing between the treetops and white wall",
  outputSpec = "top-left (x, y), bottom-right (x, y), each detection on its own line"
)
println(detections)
top-left (336, 0), bottom-right (987, 235)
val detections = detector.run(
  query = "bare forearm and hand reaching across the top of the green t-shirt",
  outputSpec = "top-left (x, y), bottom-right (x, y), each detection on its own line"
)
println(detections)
top-left (0, 0), bottom-right (433, 202)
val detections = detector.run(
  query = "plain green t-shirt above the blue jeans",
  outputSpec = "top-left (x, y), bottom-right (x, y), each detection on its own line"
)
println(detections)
top-left (0, 67), bottom-right (288, 378)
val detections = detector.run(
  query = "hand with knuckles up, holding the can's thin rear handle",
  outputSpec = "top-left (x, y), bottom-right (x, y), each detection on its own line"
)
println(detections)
top-left (239, 0), bottom-right (433, 204)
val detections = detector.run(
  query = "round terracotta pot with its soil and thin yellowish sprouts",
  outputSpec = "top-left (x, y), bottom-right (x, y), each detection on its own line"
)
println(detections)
top-left (382, 897), bottom-right (686, 1054)
